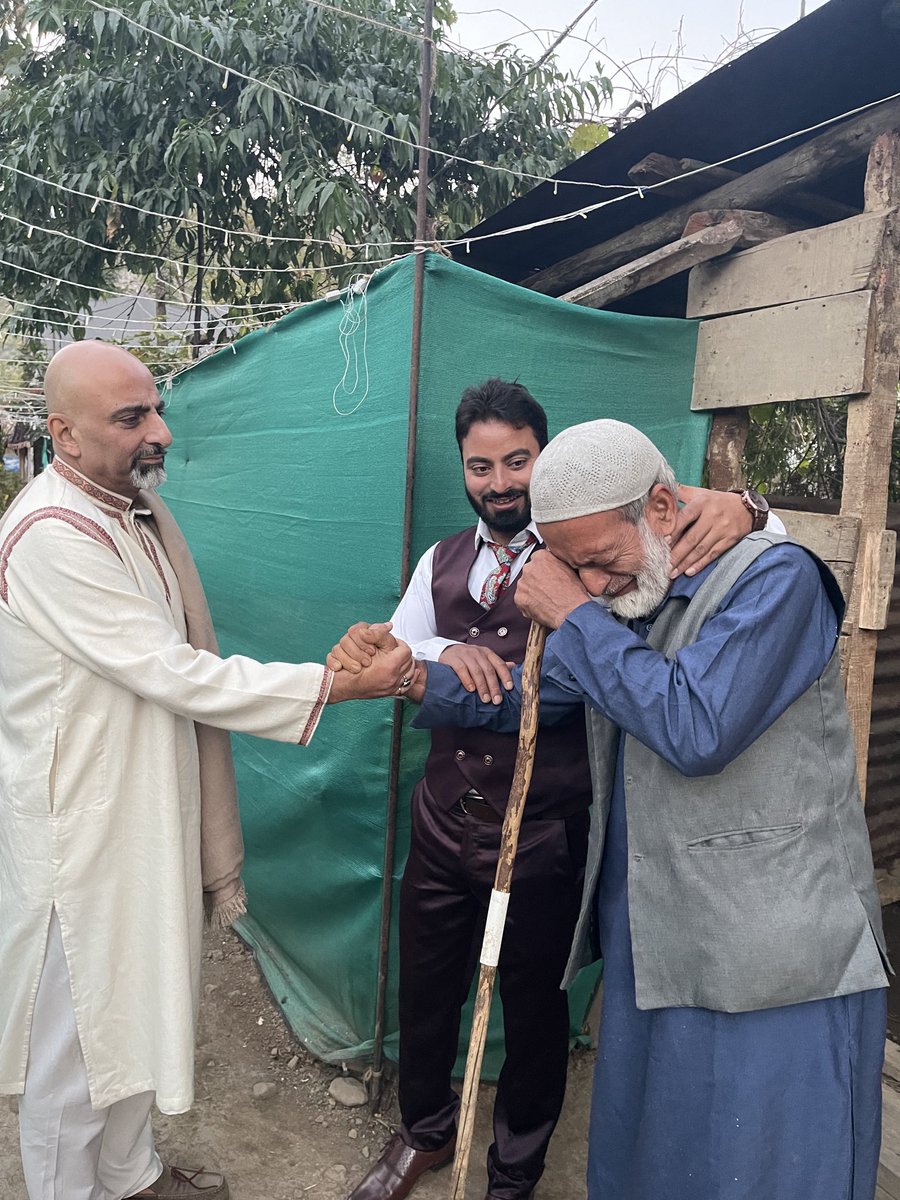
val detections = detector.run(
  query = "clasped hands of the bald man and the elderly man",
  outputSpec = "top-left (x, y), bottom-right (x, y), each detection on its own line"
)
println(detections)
top-left (325, 622), bottom-right (425, 704)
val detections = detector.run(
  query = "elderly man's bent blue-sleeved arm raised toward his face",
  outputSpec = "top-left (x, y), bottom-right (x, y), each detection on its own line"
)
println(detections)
top-left (535, 545), bottom-right (839, 775)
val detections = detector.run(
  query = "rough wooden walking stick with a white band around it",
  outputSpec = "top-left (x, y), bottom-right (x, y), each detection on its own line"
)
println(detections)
top-left (450, 620), bottom-right (547, 1200)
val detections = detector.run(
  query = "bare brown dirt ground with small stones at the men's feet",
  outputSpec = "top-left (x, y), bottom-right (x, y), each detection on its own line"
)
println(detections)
top-left (0, 934), bottom-right (593, 1200)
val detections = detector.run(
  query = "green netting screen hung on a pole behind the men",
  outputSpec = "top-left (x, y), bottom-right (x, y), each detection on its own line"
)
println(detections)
top-left (164, 254), bottom-right (708, 1078)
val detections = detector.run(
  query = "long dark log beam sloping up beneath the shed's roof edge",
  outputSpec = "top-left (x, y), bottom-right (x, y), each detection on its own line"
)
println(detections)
top-left (521, 100), bottom-right (900, 295)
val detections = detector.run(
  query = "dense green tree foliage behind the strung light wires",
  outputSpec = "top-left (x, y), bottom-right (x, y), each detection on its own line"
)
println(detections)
top-left (0, 0), bottom-right (608, 345)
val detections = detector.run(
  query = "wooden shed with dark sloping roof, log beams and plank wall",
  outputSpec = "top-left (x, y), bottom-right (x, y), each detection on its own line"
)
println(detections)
top-left (456, 0), bottom-right (900, 816)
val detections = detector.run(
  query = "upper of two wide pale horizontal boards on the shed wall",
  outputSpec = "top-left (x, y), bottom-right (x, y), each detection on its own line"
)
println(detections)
top-left (686, 211), bottom-right (898, 317)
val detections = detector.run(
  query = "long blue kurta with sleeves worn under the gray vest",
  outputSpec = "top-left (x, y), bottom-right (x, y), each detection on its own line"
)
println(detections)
top-left (420, 546), bottom-right (886, 1200)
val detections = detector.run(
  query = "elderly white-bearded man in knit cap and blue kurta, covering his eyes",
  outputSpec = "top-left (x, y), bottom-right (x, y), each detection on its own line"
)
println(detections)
top-left (415, 421), bottom-right (887, 1200)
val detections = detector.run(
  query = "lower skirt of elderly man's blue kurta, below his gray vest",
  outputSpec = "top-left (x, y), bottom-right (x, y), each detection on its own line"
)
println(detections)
top-left (588, 754), bottom-right (887, 1200)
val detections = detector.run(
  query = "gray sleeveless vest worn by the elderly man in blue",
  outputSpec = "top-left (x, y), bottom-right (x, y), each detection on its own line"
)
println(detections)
top-left (563, 532), bottom-right (887, 1013)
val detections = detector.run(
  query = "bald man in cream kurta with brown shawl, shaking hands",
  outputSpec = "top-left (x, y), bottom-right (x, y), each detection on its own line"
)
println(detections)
top-left (0, 342), bottom-right (413, 1200)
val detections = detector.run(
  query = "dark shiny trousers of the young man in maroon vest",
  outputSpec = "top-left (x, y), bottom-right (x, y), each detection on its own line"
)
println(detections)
top-left (400, 780), bottom-right (589, 1200)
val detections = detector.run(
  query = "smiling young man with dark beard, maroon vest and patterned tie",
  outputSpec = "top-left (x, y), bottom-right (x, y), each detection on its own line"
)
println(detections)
top-left (336, 379), bottom-right (787, 1200)
